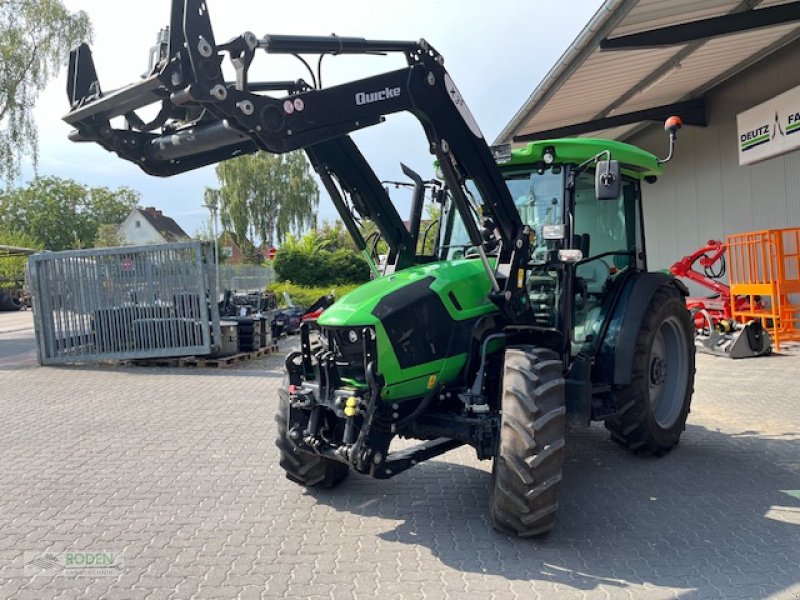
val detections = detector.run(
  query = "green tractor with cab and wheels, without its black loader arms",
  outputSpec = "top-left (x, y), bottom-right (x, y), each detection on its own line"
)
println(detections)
top-left (277, 139), bottom-right (694, 535)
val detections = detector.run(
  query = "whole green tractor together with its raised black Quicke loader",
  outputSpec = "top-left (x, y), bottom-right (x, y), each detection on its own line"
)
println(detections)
top-left (64, 0), bottom-right (694, 536)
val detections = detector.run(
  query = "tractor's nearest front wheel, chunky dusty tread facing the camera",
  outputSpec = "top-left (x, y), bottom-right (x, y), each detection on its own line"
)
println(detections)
top-left (491, 347), bottom-right (565, 537)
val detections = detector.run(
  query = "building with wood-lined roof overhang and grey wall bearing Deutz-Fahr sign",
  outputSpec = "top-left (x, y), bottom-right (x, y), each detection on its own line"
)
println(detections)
top-left (496, 0), bottom-right (800, 270)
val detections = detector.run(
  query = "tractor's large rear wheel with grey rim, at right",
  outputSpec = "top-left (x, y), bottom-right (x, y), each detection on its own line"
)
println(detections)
top-left (605, 285), bottom-right (695, 456)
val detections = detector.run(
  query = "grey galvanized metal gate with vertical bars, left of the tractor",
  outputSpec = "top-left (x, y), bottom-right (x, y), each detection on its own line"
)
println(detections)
top-left (28, 242), bottom-right (220, 365)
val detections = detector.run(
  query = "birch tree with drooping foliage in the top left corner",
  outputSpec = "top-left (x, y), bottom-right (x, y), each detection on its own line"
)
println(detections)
top-left (0, 0), bottom-right (92, 181)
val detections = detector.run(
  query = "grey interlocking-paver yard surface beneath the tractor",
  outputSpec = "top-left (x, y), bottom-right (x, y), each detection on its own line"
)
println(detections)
top-left (0, 314), bottom-right (800, 600)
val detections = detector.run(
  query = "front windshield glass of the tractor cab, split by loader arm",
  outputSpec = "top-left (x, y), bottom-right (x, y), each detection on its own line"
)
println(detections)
top-left (446, 169), bottom-right (564, 262)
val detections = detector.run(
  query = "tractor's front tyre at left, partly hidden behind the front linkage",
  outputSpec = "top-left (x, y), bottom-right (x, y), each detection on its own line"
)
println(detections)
top-left (275, 381), bottom-right (350, 488)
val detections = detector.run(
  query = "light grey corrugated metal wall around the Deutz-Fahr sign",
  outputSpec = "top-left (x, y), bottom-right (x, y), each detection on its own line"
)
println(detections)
top-left (626, 42), bottom-right (800, 270)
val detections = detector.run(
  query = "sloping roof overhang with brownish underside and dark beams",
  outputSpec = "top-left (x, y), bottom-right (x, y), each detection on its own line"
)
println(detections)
top-left (496, 0), bottom-right (800, 143)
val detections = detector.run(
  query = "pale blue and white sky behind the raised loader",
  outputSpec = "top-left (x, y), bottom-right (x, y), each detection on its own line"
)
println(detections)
top-left (23, 0), bottom-right (602, 235)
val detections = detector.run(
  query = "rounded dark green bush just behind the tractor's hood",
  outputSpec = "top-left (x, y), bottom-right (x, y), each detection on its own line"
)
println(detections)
top-left (274, 248), bottom-right (369, 287)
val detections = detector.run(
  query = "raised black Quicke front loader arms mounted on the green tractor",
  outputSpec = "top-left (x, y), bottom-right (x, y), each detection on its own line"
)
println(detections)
top-left (64, 0), bottom-right (530, 321)
